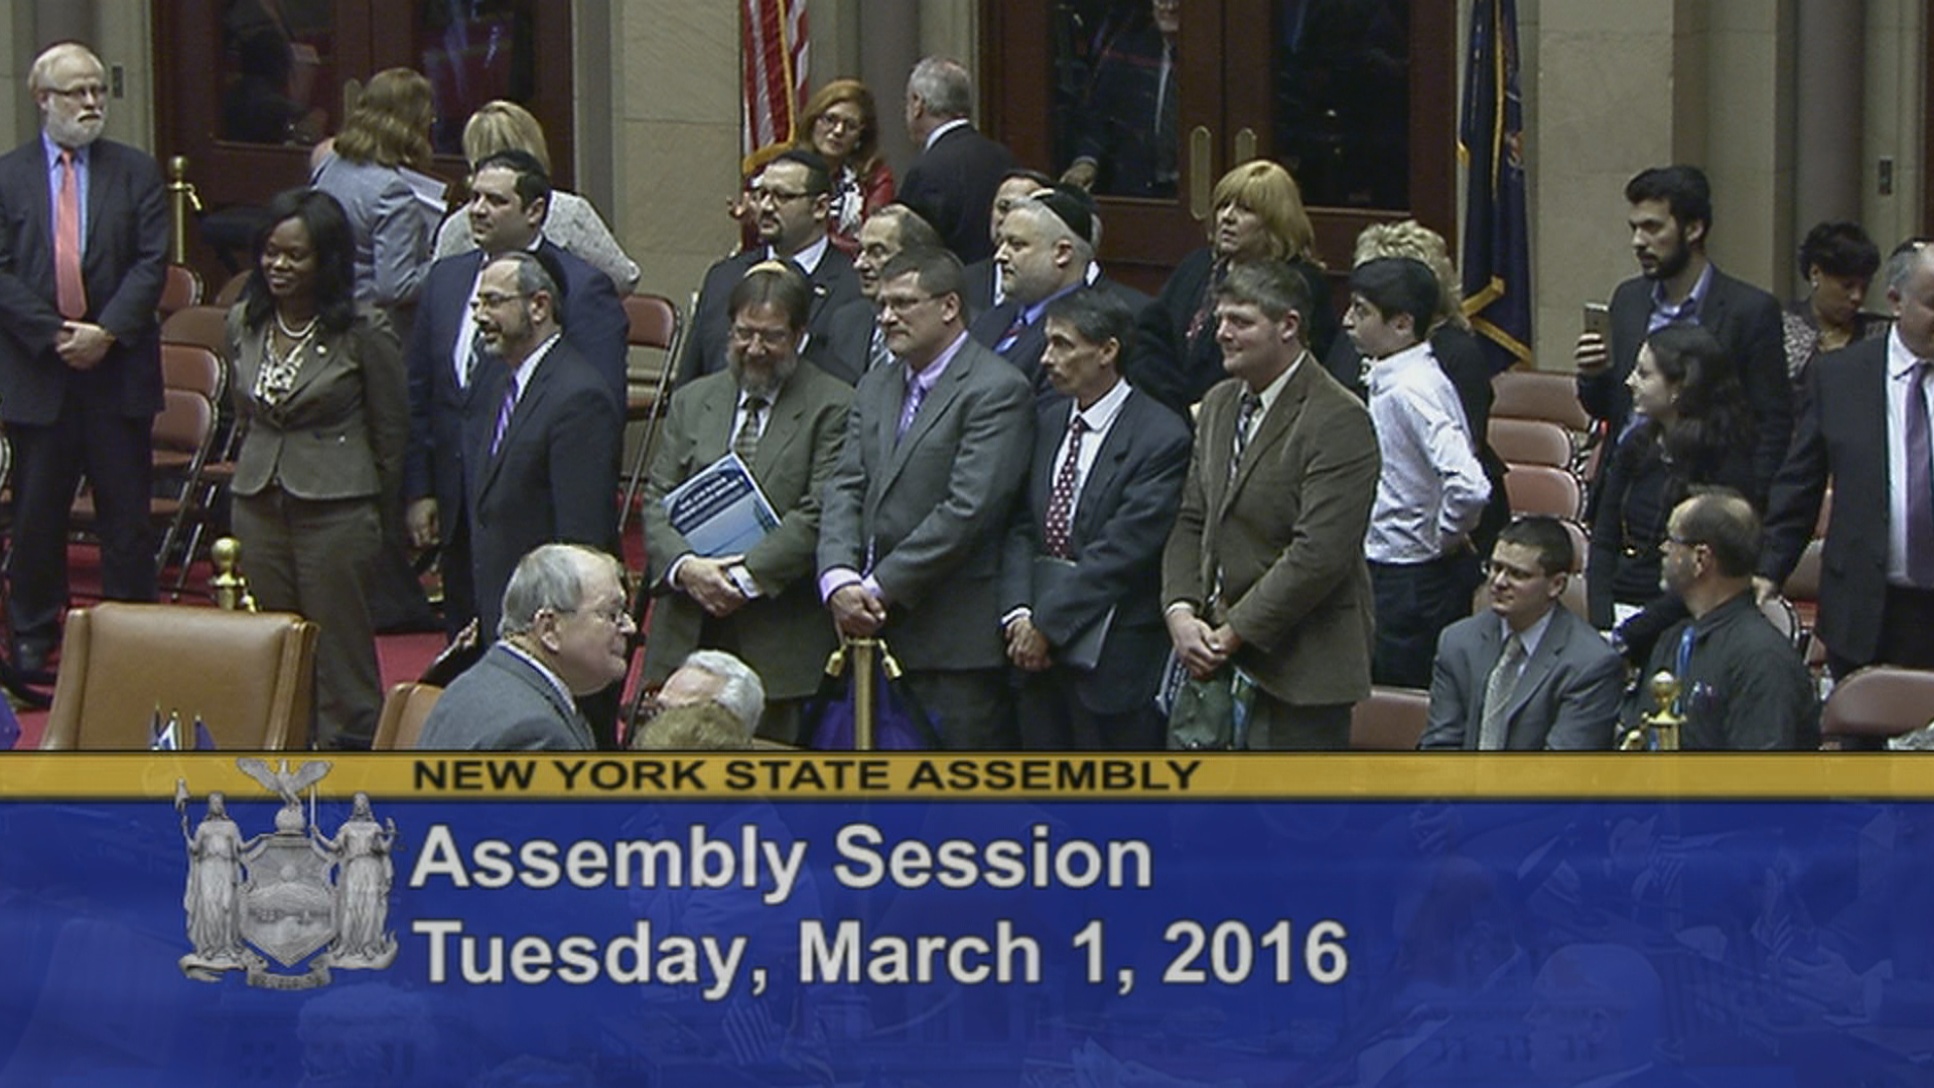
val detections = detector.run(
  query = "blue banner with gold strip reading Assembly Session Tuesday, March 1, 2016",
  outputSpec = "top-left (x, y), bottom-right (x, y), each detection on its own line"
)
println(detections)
top-left (0, 756), bottom-right (1934, 1088)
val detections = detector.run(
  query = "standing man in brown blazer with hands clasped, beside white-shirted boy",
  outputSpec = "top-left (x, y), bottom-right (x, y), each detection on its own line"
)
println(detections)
top-left (1162, 263), bottom-right (1379, 748)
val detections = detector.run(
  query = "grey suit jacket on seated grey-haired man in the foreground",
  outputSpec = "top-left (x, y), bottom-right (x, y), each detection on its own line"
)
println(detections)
top-left (416, 644), bottom-right (598, 752)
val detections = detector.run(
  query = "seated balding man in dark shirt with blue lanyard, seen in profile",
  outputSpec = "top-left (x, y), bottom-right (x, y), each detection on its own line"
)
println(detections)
top-left (1625, 491), bottom-right (1820, 750)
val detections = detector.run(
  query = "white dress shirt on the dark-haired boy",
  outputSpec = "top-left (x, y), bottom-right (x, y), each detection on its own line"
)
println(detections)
top-left (1363, 342), bottom-right (1491, 562)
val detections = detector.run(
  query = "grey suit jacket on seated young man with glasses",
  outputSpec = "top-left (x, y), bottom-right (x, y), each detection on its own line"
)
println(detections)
top-left (1418, 605), bottom-right (1625, 750)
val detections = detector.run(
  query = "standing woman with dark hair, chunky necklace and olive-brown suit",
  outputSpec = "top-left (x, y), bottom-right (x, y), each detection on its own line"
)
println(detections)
top-left (228, 189), bottom-right (410, 748)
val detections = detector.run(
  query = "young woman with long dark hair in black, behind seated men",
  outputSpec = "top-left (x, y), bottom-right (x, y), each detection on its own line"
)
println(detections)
top-left (1586, 325), bottom-right (1766, 661)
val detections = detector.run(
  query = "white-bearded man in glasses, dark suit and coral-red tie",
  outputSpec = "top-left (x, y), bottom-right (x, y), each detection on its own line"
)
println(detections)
top-left (0, 43), bottom-right (168, 674)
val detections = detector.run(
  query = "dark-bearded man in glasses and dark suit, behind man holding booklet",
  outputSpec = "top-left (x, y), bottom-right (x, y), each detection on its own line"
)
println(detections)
top-left (679, 151), bottom-right (864, 385)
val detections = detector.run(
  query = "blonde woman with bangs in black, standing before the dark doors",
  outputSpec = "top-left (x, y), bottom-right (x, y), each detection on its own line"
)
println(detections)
top-left (1128, 158), bottom-right (1336, 415)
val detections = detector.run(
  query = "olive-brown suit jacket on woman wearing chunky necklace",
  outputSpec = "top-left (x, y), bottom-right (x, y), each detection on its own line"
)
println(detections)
top-left (228, 305), bottom-right (410, 499)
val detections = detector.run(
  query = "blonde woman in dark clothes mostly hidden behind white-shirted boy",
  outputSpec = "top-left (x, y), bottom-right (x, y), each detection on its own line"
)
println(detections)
top-left (1323, 218), bottom-right (1510, 557)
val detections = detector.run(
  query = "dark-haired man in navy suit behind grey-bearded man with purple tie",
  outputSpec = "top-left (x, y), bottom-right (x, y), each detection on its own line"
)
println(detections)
top-left (402, 151), bottom-right (630, 642)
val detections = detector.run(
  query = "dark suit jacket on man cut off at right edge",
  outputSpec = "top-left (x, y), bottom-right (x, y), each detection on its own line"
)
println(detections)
top-left (1760, 336), bottom-right (1891, 665)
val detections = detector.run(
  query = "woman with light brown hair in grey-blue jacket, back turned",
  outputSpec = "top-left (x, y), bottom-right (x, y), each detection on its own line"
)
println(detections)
top-left (309, 68), bottom-right (439, 322)
